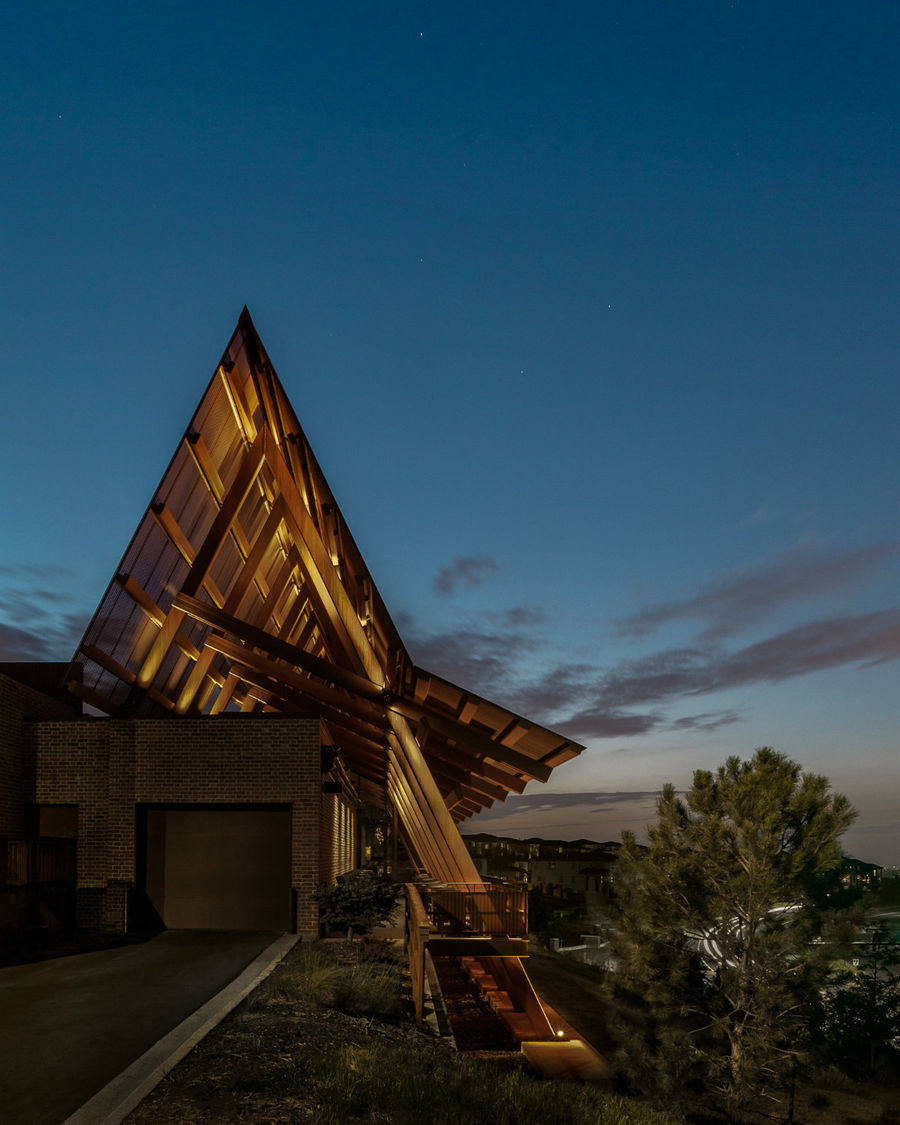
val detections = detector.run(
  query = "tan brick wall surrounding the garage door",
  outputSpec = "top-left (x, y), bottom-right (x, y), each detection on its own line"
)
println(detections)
top-left (35, 714), bottom-right (324, 934)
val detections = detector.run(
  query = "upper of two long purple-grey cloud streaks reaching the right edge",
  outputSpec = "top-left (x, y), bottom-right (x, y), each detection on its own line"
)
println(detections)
top-left (617, 542), bottom-right (900, 640)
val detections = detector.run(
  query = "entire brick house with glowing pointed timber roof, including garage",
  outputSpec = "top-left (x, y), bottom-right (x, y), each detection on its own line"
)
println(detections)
top-left (0, 309), bottom-right (582, 934)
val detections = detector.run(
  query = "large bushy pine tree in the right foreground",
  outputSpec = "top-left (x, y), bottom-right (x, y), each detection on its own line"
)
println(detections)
top-left (613, 747), bottom-right (855, 1119)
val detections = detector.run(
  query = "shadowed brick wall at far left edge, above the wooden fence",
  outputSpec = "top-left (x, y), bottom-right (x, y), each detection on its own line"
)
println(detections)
top-left (0, 665), bottom-right (73, 839)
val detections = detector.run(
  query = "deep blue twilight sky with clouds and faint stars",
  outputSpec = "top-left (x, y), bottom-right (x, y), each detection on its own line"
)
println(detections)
top-left (0, 0), bottom-right (900, 863)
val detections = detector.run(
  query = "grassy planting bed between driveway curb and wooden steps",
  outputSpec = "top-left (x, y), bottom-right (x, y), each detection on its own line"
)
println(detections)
top-left (127, 942), bottom-right (673, 1125)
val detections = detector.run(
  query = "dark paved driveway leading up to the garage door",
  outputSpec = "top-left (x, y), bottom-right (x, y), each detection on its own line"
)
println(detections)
top-left (0, 930), bottom-right (277, 1125)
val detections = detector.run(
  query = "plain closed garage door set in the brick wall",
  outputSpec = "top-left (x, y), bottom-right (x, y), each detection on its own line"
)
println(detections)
top-left (145, 809), bottom-right (291, 930)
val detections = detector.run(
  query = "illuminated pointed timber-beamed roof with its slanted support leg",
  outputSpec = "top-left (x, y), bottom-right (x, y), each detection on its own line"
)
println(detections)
top-left (68, 309), bottom-right (583, 882)
